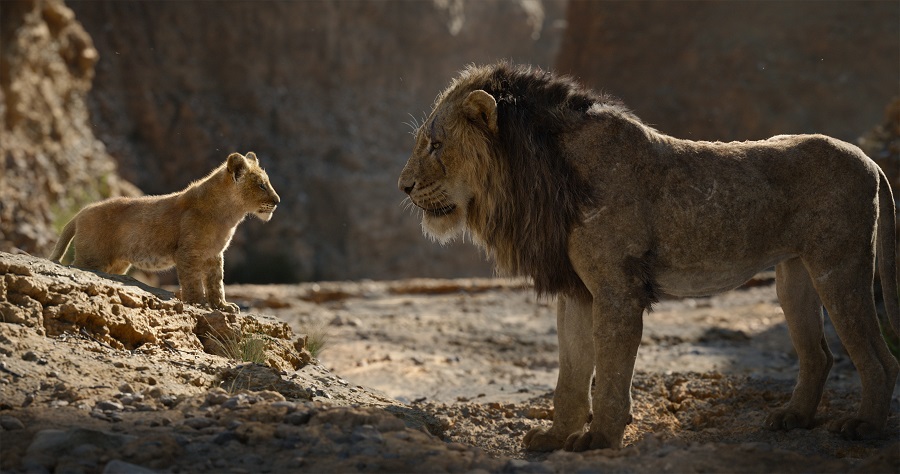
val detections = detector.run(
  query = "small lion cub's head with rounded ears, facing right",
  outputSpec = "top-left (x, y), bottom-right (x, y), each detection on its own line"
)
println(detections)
top-left (225, 151), bottom-right (281, 222)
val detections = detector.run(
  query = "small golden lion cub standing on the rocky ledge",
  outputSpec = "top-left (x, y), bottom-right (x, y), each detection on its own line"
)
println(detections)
top-left (50, 152), bottom-right (281, 312)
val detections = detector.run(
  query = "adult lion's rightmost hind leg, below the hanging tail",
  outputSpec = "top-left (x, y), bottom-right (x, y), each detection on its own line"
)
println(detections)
top-left (810, 258), bottom-right (900, 439)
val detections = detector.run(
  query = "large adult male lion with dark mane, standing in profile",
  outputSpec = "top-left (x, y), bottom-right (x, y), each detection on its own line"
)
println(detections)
top-left (398, 63), bottom-right (900, 451)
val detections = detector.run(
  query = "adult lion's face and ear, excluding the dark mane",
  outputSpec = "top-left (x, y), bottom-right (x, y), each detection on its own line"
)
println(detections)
top-left (397, 83), bottom-right (500, 243)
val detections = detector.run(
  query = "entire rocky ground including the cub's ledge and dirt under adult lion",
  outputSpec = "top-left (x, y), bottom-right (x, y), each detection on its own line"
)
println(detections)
top-left (0, 253), bottom-right (900, 473)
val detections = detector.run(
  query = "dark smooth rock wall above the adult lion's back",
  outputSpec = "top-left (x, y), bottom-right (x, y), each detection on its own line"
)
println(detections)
top-left (556, 0), bottom-right (900, 142)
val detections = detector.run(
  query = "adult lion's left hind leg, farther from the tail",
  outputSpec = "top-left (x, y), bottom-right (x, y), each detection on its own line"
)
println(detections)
top-left (765, 258), bottom-right (834, 430)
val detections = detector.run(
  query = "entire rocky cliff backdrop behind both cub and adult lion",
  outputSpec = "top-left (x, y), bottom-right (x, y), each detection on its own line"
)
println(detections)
top-left (0, 0), bottom-right (900, 282)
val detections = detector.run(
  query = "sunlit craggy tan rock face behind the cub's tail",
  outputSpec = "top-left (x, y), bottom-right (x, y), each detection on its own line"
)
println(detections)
top-left (0, 0), bottom-right (138, 255)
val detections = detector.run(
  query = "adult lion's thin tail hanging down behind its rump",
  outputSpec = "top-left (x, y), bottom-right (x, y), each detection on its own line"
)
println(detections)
top-left (877, 170), bottom-right (900, 336)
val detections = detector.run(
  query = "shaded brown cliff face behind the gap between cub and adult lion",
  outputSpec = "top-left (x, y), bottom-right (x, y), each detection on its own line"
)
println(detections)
top-left (70, 0), bottom-right (564, 281)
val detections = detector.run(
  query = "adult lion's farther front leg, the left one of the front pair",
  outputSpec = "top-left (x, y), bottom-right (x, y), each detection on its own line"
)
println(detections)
top-left (523, 296), bottom-right (594, 451)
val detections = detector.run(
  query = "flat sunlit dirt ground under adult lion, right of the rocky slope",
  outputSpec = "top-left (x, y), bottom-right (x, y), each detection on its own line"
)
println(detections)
top-left (229, 274), bottom-right (900, 472)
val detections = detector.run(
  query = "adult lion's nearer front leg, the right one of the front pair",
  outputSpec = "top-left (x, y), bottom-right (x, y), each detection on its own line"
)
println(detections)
top-left (565, 295), bottom-right (644, 451)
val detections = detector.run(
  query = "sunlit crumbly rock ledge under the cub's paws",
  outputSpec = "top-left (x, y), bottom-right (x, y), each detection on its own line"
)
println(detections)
top-left (0, 252), bottom-right (310, 370)
